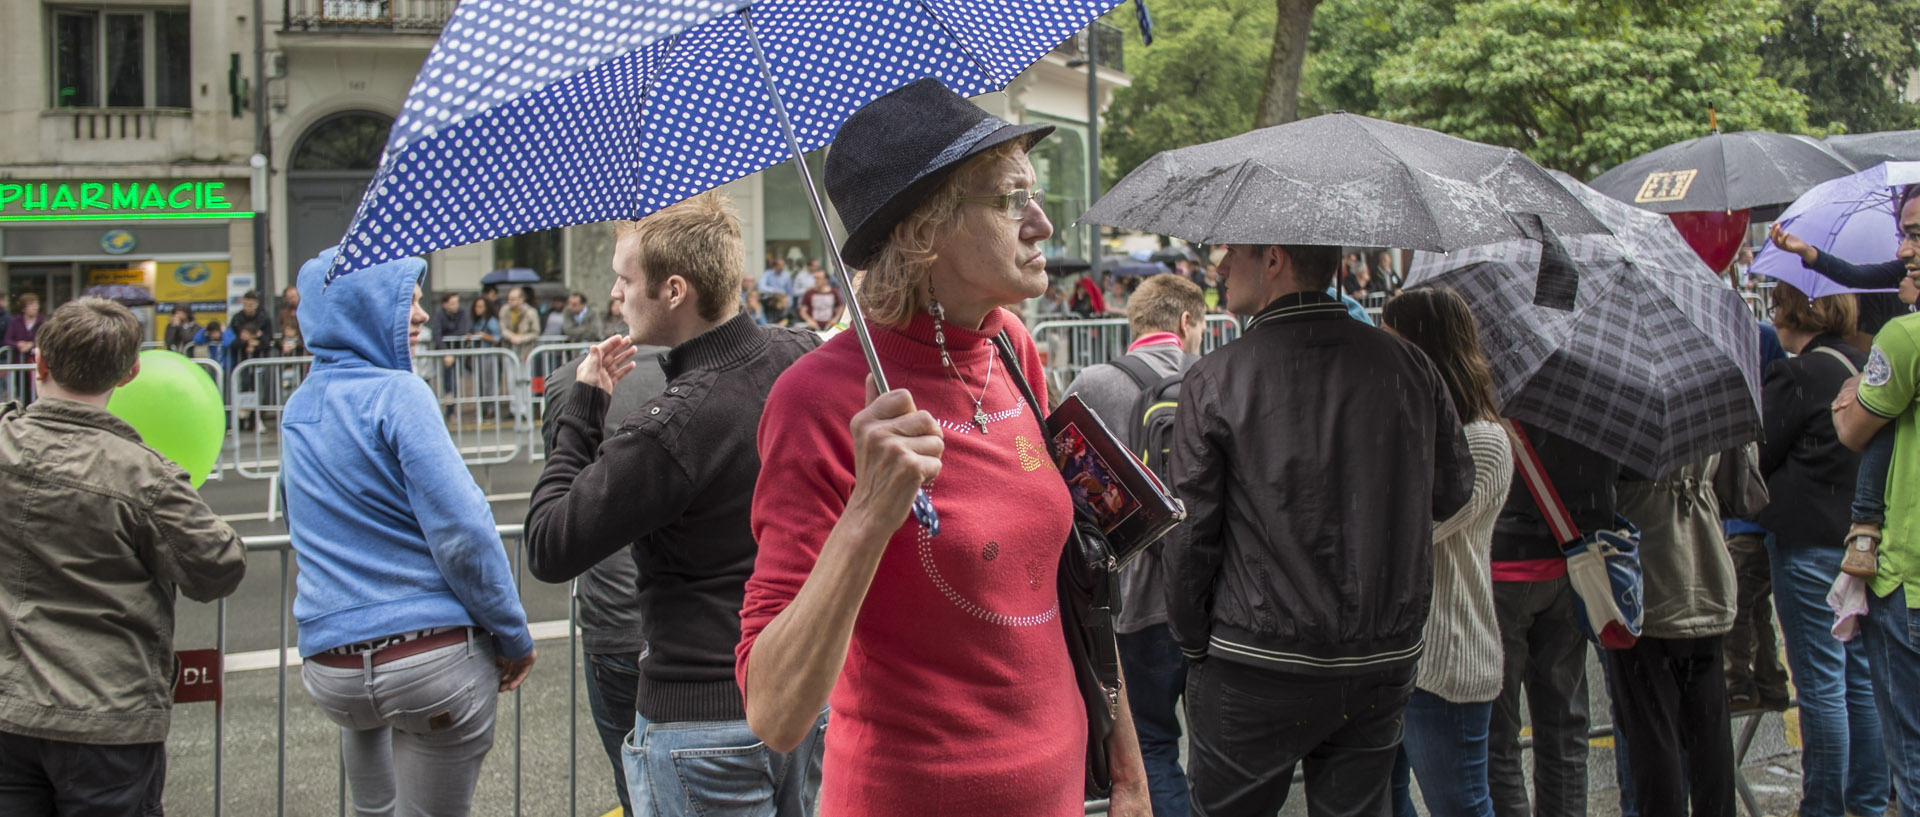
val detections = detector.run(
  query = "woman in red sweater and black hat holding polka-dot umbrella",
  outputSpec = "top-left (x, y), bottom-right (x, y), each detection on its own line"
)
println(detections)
top-left (737, 79), bottom-right (1150, 817)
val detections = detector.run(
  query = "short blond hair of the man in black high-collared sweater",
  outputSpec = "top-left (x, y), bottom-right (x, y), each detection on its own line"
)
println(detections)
top-left (612, 190), bottom-right (747, 320)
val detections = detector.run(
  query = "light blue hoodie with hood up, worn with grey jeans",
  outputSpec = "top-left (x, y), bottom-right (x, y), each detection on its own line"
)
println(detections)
top-left (280, 249), bottom-right (534, 658)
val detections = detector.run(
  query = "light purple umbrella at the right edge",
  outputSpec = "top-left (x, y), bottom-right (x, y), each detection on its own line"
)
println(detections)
top-left (1747, 161), bottom-right (1920, 297)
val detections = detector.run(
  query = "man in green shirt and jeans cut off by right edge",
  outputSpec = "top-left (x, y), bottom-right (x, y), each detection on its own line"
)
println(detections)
top-left (1834, 188), bottom-right (1920, 815)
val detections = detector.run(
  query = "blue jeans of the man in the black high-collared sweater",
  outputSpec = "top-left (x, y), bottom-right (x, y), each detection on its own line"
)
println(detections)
top-left (620, 710), bottom-right (828, 817)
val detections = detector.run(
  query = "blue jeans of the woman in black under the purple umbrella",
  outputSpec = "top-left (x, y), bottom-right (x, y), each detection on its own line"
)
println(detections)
top-left (1766, 537), bottom-right (1887, 817)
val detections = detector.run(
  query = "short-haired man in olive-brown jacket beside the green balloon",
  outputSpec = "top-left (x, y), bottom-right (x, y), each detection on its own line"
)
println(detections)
top-left (0, 297), bottom-right (246, 815)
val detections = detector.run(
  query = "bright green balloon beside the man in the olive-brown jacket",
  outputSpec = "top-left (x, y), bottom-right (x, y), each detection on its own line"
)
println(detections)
top-left (108, 349), bottom-right (227, 487)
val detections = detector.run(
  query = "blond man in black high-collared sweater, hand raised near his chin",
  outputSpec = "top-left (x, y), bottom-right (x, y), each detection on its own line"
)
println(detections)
top-left (526, 194), bottom-right (826, 817)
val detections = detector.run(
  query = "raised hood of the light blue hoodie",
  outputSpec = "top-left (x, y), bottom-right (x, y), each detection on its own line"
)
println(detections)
top-left (298, 247), bottom-right (426, 370)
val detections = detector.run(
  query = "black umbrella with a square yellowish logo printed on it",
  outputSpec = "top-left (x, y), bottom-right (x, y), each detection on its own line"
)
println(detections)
top-left (1590, 130), bottom-right (1855, 213)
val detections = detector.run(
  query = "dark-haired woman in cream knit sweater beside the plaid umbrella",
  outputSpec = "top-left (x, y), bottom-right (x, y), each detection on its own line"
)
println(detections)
top-left (1380, 288), bottom-right (1513, 817)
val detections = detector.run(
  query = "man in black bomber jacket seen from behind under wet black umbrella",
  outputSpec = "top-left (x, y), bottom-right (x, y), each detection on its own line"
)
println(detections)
top-left (1162, 245), bottom-right (1473, 817)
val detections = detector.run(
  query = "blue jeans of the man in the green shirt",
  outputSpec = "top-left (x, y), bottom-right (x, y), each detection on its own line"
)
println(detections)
top-left (1862, 589), bottom-right (1920, 815)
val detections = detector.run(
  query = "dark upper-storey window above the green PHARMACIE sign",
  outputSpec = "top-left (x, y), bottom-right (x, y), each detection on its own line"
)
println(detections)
top-left (48, 8), bottom-right (192, 107)
